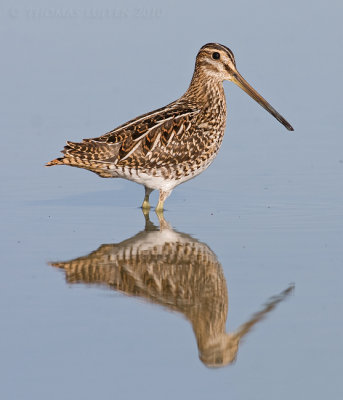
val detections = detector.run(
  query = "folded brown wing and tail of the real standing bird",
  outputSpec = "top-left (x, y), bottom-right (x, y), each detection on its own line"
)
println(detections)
top-left (47, 102), bottom-right (201, 170)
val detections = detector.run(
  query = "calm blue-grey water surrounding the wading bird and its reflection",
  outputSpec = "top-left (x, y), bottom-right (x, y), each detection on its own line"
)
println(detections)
top-left (0, 0), bottom-right (343, 400)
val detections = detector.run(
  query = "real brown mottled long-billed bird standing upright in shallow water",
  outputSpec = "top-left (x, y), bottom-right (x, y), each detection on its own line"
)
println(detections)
top-left (46, 43), bottom-right (294, 213)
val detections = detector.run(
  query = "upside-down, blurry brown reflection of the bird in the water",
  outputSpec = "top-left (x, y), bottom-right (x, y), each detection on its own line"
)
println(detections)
top-left (50, 215), bottom-right (293, 367)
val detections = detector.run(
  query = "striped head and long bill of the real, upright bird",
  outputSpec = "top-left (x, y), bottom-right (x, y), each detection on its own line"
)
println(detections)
top-left (195, 43), bottom-right (293, 131)
